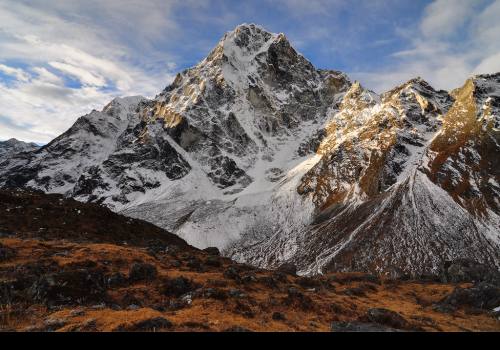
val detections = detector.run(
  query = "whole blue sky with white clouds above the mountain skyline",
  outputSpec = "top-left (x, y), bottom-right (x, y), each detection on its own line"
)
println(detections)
top-left (0, 0), bottom-right (500, 143)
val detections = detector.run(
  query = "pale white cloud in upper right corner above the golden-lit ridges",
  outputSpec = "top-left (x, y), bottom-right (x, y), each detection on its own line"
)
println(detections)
top-left (352, 0), bottom-right (500, 92)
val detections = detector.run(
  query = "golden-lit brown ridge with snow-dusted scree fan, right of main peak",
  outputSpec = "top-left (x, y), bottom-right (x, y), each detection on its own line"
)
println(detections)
top-left (230, 74), bottom-right (500, 275)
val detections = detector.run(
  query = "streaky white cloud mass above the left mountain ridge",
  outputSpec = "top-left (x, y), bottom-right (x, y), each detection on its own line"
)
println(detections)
top-left (0, 0), bottom-right (178, 142)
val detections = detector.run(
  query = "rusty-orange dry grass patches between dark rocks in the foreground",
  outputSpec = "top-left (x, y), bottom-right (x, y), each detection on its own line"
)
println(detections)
top-left (0, 238), bottom-right (500, 332)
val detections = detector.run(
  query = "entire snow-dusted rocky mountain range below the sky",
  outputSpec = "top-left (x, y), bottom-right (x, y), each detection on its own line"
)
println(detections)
top-left (0, 25), bottom-right (500, 275)
